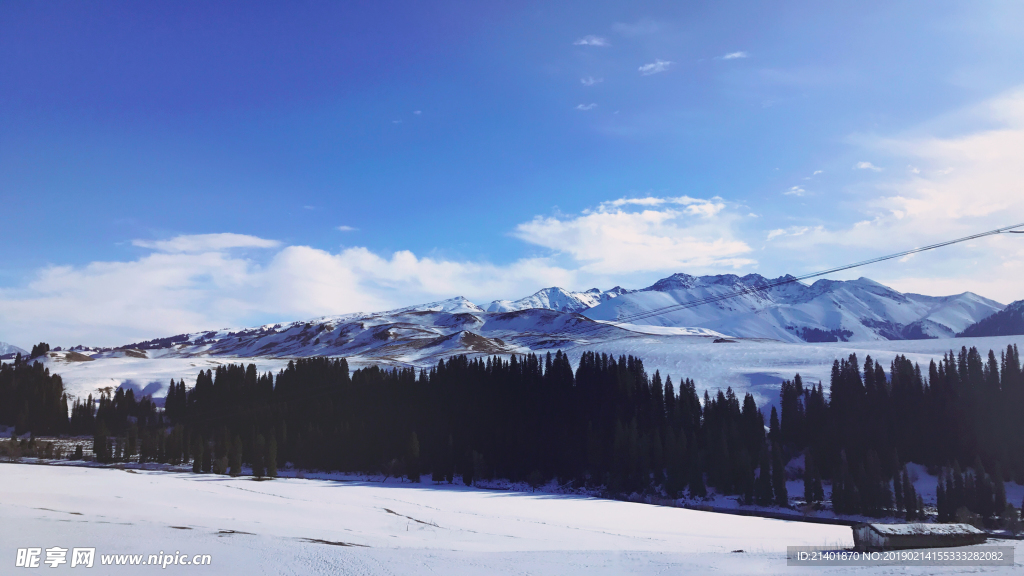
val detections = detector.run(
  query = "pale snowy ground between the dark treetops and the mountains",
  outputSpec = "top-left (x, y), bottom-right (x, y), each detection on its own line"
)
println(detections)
top-left (39, 326), bottom-right (1024, 405)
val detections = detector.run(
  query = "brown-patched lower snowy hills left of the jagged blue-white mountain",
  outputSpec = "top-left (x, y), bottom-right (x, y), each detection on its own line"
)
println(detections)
top-left (70, 296), bottom-right (638, 366)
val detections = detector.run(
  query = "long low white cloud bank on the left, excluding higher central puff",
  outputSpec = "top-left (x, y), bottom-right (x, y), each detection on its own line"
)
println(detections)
top-left (0, 237), bottom-right (575, 345)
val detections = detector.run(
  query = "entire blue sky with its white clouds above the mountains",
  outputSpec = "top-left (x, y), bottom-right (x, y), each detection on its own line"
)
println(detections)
top-left (0, 1), bottom-right (1024, 346)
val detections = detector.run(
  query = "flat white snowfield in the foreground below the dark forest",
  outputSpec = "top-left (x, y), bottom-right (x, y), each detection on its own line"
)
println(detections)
top-left (0, 463), bottom-right (1024, 575)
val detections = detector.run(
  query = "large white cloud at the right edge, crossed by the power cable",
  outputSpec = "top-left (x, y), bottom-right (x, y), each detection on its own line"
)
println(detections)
top-left (776, 89), bottom-right (1024, 302)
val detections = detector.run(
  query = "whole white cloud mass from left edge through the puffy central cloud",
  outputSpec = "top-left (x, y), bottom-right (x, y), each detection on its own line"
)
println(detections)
top-left (0, 196), bottom-right (753, 345)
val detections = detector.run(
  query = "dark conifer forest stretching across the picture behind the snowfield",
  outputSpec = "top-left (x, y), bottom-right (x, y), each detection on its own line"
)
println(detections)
top-left (0, 346), bottom-right (1024, 521)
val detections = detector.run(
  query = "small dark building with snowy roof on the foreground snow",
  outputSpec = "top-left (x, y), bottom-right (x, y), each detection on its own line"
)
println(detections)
top-left (853, 523), bottom-right (987, 550)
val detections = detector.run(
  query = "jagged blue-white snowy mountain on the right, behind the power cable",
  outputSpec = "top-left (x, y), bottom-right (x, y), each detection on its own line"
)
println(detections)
top-left (584, 274), bottom-right (1002, 342)
